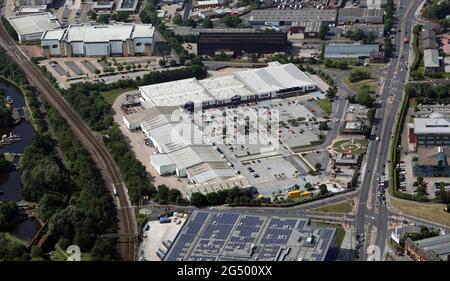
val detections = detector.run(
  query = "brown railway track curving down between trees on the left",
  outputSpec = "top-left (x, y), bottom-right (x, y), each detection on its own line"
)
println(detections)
top-left (0, 25), bottom-right (137, 261)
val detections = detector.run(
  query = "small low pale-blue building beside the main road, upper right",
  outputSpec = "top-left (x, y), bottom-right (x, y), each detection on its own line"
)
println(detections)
top-left (324, 44), bottom-right (380, 59)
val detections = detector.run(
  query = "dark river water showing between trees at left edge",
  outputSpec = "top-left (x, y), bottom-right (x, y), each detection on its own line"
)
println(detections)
top-left (0, 82), bottom-right (40, 240)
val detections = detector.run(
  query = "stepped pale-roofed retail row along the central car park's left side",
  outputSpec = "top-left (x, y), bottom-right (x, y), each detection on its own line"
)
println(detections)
top-left (123, 105), bottom-right (244, 188)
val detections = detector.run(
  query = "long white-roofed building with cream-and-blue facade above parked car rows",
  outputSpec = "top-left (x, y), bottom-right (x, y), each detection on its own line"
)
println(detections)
top-left (41, 24), bottom-right (155, 57)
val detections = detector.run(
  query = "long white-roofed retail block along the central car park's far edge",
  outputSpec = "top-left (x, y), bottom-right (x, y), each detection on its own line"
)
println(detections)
top-left (139, 62), bottom-right (316, 108)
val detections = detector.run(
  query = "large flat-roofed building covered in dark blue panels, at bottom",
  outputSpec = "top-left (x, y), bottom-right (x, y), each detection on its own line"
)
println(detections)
top-left (164, 210), bottom-right (339, 261)
